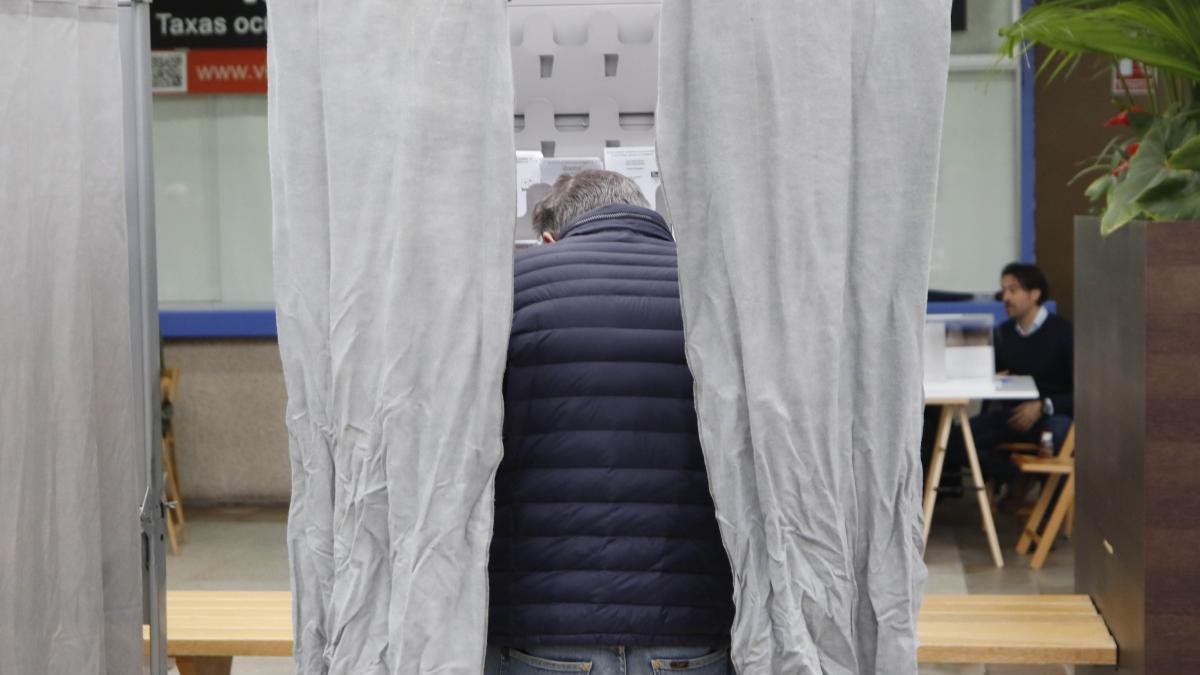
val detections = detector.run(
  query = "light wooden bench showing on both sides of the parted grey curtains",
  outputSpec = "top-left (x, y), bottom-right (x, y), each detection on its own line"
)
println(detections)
top-left (145, 591), bottom-right (1117, 675)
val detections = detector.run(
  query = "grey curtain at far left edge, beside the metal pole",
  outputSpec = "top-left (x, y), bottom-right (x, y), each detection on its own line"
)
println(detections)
top-left (0, 0), bottom-right (143, 675)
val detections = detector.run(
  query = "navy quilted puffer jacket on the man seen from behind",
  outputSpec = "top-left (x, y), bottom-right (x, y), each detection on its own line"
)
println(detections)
top-left (490, 205), bottom-right (733, 647)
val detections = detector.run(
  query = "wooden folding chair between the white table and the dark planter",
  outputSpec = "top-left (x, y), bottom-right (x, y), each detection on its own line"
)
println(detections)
top-left (1003, 424), bottom-right (1075, 569)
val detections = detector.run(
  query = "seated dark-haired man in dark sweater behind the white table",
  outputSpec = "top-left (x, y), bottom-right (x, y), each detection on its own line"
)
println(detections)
top-left (948, 263), bottom-right (1075, 504)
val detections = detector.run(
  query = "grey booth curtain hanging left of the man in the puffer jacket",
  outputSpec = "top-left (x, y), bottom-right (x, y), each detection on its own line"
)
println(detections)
top-left (269, 0), bottom-right (515, 674)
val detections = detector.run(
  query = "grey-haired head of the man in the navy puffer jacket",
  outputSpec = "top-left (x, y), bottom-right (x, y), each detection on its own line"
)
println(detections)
top-left (533, 171), bottom-right (650, 239)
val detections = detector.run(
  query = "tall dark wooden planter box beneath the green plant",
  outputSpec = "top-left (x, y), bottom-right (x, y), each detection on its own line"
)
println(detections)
top-left (1074, 217), bottom-right (1200, 675)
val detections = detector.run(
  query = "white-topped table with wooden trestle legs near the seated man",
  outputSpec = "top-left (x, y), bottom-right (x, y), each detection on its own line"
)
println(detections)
top-left (925, 376), bottom-right (1038, 567)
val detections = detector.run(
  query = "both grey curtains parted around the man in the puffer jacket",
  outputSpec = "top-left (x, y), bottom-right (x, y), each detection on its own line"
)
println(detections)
top-left (270, 0), bottom-right (949, 675)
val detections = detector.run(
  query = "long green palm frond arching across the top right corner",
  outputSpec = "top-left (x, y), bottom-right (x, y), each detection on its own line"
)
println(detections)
top-left (1001, 0), bottom-right (1200, 82)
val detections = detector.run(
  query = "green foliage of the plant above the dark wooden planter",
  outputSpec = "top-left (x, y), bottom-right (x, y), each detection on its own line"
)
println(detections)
top-left (1001, 0), bottom-right (1200, 234)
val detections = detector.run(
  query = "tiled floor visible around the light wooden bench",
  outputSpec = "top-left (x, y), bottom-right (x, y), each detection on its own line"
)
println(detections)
top-left (167, 498), bottom-right (1074, 675)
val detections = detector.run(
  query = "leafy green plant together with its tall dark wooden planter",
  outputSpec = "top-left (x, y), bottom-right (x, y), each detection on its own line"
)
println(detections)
top-left (1001, 0), bottom-right (1200, 674)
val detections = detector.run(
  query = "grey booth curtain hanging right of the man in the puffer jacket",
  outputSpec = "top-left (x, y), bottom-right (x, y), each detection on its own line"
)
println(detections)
top-left (658, 0), bottom-right (949, 675)
